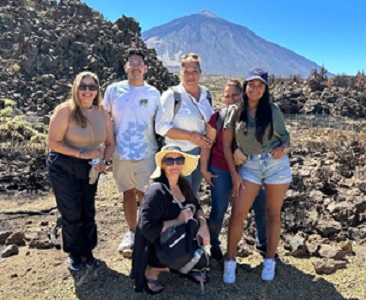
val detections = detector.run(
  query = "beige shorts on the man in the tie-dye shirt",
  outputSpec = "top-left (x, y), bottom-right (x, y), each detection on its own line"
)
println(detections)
top-left (113, 155), bottom-right (156, 193)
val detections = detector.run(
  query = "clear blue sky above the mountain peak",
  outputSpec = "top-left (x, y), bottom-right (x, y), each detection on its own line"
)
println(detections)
top-left (84, 0), bottom-right (366, 75)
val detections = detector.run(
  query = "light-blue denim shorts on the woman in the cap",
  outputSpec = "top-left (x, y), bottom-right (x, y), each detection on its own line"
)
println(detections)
top-left (239, 153), bottom-right (292, 185)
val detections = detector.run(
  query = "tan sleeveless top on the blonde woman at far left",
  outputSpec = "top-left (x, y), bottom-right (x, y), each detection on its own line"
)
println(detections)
top-left (63, 105), bottom-right (107, 151)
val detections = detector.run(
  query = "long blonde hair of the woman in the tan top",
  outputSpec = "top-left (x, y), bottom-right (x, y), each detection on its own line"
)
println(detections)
top-left (55, 71), bottom-right (103, 128)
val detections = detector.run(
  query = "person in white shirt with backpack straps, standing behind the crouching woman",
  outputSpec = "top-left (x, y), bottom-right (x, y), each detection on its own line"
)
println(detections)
top-left (155, 53), bottom-right (213, 197)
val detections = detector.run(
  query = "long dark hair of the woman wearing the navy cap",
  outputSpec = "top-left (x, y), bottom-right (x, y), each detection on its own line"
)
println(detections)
top-left (236, 81), bottom-right (273, 144)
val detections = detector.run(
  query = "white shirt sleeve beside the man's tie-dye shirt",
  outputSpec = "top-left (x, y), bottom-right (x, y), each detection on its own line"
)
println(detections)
top-left (155, 90), bottom-right (174, 136)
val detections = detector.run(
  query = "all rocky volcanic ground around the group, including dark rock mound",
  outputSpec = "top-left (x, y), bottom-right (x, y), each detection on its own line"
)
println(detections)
top-left (0, 0), bottom-right (366, 299)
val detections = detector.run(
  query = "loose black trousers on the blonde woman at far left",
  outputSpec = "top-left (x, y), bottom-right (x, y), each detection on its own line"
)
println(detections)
top-left (47, 152), bottom-right (98, 255)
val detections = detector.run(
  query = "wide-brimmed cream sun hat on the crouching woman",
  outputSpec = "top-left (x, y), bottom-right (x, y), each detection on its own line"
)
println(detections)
top-left (150, 145), bottom-right (200, 179)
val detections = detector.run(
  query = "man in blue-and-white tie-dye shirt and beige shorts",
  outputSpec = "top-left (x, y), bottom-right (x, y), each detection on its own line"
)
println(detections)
top-left (104, 49), bottom-right (160, 252)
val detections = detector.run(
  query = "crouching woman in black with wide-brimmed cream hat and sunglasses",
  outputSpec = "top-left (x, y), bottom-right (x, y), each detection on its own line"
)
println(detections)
top-left (132, 145), bottom-right (210, 294)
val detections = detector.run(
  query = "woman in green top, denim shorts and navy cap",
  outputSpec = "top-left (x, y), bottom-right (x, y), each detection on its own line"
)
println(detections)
top-left (223, 68), bottom-right (292, 283)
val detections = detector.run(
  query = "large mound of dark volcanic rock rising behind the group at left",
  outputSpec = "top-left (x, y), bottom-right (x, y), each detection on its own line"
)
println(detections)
top-left (0, 0), bottom-right (177, 116)
